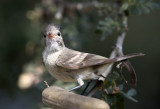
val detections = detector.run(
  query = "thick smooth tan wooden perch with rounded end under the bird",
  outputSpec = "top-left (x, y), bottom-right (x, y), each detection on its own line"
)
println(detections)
top-left (42, 86), bottom-right (109, 109)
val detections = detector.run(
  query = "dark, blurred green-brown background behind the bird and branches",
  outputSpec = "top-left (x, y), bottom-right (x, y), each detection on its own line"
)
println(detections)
top-left (0, 0), bottom-right (160, 109)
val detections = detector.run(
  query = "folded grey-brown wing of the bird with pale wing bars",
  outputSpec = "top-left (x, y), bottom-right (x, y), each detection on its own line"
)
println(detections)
top-left (56, 48), bottom-right (116, 69)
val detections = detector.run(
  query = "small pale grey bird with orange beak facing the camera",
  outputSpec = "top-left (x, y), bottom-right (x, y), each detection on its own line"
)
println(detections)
top-left (43, 24), bottom-right (143, 91)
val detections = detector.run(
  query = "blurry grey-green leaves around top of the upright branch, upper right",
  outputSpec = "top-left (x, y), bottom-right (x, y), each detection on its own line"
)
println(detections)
top-left (96, 0), bottom-right (160, 40)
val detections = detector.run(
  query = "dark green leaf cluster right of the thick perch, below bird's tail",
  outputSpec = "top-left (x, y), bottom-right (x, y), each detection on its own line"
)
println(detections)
top-left (101, 71), bottom-right (138, 109)
